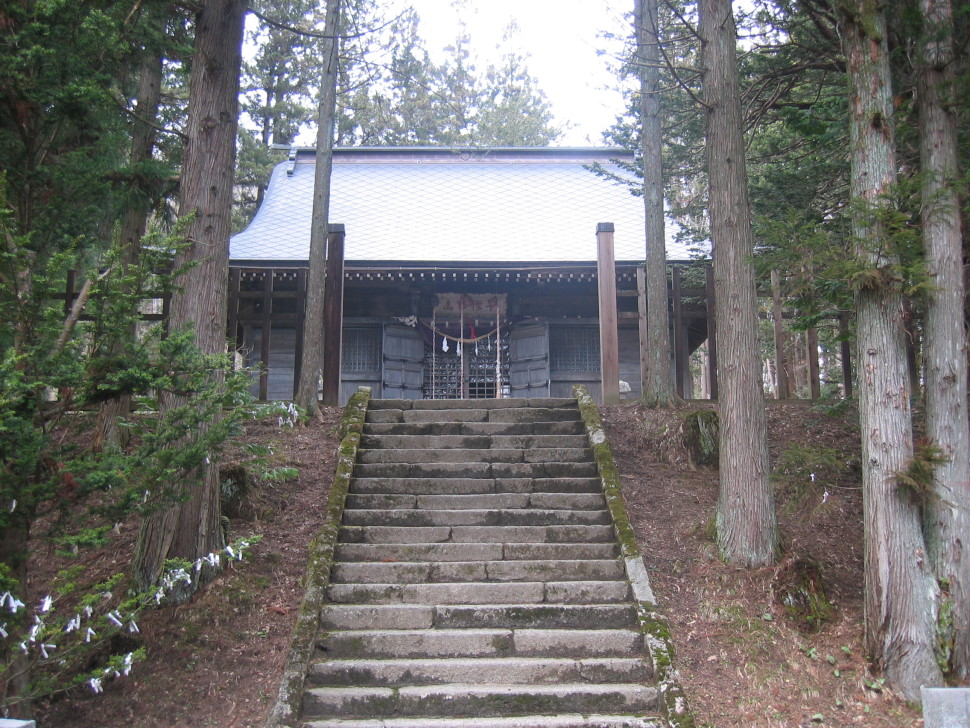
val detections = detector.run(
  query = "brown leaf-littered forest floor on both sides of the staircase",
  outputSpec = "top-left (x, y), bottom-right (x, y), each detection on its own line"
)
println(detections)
top-left (30, 402), bottom-right (936, 728)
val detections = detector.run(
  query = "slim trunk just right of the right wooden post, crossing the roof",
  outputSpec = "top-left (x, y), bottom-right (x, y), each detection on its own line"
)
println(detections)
top-left (635, 0), bottom-right (677, 407)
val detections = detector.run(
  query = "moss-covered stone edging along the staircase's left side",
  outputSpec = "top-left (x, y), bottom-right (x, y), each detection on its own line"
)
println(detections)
top-left (266, 387), bottom-right (371, 728)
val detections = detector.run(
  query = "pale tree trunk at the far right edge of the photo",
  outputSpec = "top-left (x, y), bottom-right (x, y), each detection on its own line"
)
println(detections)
top-left (917, 0), bottom-right (970, 678)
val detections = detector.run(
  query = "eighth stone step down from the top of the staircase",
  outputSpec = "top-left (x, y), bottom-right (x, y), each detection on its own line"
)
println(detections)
top-left (346, 493), bottom-right (606, 511)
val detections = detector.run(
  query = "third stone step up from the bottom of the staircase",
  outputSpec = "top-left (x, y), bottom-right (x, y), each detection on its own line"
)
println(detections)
top-left (308, 657), bottom-right (653, 687)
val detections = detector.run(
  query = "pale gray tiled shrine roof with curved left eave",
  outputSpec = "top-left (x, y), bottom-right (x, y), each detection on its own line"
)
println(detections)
top-left (230, 148), bottom-right (688, 262)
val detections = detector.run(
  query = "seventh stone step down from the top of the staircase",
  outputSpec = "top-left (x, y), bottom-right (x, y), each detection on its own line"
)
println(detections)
top-left (350, 478), bottom-right (602, 495)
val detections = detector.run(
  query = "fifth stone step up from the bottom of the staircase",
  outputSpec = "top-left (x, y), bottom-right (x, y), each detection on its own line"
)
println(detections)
top-left (322, 604), bottom-right (637, 632)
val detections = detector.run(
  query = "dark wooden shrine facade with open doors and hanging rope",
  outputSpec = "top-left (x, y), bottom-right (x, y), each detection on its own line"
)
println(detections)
top-left (229, 255), bottom-right (716, 403)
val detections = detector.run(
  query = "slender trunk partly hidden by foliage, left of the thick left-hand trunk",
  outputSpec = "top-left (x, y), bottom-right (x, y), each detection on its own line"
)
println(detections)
top-left (91, 55), bottom-right (162, 452)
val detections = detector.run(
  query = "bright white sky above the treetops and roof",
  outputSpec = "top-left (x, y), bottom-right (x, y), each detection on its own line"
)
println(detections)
top-left (388, 0), bottom-right (633, 146)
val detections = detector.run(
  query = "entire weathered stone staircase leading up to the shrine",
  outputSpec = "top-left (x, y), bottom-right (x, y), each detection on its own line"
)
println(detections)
top-left (301, 399), bottom-right (666, 728)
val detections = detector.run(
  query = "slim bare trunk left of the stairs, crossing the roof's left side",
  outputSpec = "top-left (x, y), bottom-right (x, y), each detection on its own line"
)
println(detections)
top-left (296, 0), bottom-right (340, 416)
